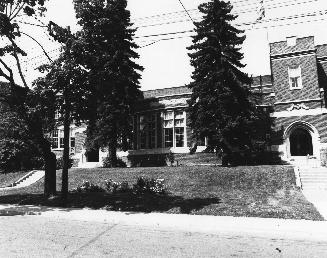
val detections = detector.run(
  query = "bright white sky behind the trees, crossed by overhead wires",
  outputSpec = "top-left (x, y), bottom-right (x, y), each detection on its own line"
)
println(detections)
top-left (1, 0), bottom-right (327, 90)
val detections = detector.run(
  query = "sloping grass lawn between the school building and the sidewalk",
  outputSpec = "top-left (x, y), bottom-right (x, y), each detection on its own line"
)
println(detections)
top-left (0, 166), bottom-right (323, 220)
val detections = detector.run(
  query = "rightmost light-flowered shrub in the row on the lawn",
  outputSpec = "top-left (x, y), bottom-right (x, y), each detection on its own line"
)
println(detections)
top-left (133, 177), bottom-right (167, 194)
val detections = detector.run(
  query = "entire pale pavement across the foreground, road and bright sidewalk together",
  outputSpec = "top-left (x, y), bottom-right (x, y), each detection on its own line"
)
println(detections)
top-left (0, 206), bottom-right (327, 257)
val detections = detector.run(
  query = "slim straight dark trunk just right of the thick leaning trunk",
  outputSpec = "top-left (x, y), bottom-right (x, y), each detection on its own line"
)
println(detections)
top-left (61, 102), bottom-right (70, 205)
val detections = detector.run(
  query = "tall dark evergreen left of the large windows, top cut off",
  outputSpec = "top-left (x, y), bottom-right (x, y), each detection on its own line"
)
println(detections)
top-left (74, 0), bottom-right (143, 166)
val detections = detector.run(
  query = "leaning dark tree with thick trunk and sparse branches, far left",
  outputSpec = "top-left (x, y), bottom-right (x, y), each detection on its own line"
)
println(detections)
top-left (0, 0), bottom-right (56, 196)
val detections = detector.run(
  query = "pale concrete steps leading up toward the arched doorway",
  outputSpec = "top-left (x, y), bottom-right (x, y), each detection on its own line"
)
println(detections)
top-left (299, 167), bottom-right (327, 190)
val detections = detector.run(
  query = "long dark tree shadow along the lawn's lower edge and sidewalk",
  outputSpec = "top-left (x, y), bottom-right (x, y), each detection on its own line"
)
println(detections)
top-left (0, 193), bottom-right (221, 216)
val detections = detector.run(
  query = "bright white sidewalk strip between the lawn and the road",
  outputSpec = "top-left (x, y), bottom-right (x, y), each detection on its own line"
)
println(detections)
top-left (0, 205), bottom-right (327, 242)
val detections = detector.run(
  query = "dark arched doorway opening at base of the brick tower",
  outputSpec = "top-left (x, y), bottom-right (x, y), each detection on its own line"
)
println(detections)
top-left (290, 128), bottom-right (313, 156)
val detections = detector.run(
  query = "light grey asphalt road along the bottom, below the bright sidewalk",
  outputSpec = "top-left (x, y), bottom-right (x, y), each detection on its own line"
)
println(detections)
top-left (0, 215), bottom-right (327, 258)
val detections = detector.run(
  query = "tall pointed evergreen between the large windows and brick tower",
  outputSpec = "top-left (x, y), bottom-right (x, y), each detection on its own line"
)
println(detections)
top-left (188, 0), bottom-right (256, 163)
